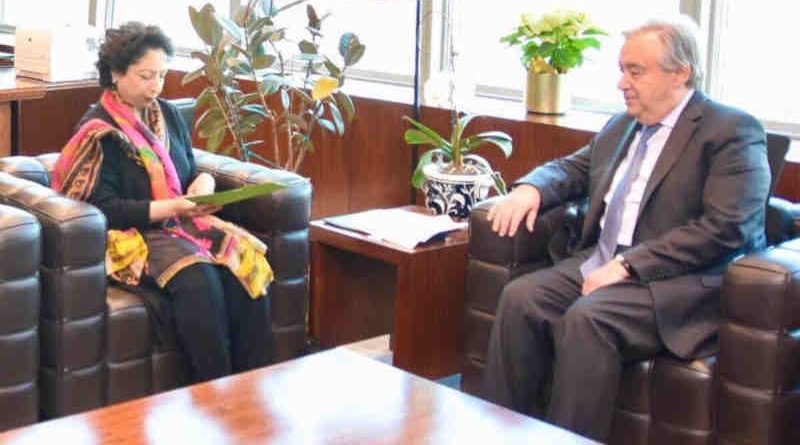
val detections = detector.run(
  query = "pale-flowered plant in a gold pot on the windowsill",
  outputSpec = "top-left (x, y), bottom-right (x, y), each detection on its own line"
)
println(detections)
top-left (500, 9), bottom-right (605, 114)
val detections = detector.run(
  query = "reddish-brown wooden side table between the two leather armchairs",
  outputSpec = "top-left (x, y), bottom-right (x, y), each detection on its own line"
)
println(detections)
top-left (309, 206), bottom-right (468, 378)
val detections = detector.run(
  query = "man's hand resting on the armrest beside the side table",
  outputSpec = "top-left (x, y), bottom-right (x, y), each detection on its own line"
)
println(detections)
top-left (486, 184), bottom-right (542, 236)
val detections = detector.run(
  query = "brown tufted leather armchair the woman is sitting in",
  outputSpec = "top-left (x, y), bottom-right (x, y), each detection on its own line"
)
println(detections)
top-left (0, 134), bottom-right (311, 418)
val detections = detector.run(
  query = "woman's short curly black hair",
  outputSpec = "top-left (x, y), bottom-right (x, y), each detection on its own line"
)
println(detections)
top-left (95, 22), bottom-right (174, 88)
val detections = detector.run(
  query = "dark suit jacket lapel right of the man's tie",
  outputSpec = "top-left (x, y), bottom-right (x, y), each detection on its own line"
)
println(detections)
top-left (639, 92), bottom-right (705, 215)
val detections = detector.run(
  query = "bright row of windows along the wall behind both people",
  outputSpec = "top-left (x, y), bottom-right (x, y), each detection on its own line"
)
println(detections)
top-left (0, 0), bottom-right (800, 139)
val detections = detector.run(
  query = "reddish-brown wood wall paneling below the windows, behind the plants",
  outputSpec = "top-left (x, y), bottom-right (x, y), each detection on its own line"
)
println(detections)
top-left (163, 72), bottom-right (593, 218)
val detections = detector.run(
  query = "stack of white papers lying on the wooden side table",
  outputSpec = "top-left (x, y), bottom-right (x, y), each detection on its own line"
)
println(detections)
top-left (325, 209), bottom-right (467, 249)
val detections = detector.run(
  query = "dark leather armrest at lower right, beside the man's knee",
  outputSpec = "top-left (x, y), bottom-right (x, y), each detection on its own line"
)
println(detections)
top-left (716, 239), bottom-right (800, 443)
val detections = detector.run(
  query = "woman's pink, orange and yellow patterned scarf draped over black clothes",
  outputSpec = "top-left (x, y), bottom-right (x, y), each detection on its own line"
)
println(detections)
top-left (53, 90), bottom-right (273, 298)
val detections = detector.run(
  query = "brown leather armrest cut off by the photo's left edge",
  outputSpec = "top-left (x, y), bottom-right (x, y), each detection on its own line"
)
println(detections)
top-left (0, 205), bottom-right (41, 431)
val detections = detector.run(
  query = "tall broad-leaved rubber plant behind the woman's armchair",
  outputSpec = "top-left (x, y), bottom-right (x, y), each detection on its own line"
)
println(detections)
top-left (183, 0), bottom-right (365, 171)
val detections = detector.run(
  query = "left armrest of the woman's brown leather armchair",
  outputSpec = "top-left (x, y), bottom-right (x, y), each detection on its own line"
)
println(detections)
top-left (0, 172), bottom-right (106, 417)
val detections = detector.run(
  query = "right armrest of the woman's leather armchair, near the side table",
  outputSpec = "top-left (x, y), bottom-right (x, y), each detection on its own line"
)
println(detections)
top-left (194, 149), bottom-right (311, 360)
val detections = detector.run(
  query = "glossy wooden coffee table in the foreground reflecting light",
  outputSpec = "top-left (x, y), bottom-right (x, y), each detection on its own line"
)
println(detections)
top-left (0, 348), bottom-right (594, 445)
